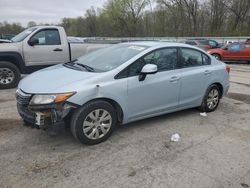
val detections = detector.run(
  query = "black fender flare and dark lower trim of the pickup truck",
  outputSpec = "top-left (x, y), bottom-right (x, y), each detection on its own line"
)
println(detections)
top-left (0, 52), bottom-right (52, 74)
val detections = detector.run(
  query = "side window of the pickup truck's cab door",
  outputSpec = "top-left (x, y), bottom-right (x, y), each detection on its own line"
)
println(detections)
top-left (32, 29), bottom-right (61, 45)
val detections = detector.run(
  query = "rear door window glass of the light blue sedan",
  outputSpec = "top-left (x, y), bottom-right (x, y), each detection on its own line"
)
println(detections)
top-left (181, 48), bottom-right (203, 67)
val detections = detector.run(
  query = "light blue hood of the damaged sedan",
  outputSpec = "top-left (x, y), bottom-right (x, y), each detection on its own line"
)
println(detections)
top-left (18, 65), bottom-right (102, 94)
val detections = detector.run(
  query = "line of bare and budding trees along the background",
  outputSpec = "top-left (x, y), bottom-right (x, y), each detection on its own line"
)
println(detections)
top-left (0, 0), bottom-right (250, 37)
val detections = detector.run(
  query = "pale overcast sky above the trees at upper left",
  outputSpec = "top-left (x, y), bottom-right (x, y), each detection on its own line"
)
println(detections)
top-left (0, 0), bottom-right (106, 26)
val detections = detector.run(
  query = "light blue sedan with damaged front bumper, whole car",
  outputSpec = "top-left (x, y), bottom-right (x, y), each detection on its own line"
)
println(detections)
top-left (16, 42), bottom-right (230, 144)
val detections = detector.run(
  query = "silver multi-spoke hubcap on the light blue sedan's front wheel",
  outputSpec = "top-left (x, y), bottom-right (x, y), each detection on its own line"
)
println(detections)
top-left (83, 109), bottom-right (112, 140)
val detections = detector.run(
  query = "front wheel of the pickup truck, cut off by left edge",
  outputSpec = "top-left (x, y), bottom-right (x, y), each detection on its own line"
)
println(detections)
top-left (0, 61), bottom-right (21, 89)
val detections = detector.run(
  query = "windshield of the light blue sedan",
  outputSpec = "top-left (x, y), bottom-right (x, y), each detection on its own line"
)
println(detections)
top-left (76, 44), bottom-right (147, 72)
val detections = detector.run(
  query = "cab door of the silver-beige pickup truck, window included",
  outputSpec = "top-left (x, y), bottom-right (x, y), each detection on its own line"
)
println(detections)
top-left (23, 28), bottom-right (69, 66)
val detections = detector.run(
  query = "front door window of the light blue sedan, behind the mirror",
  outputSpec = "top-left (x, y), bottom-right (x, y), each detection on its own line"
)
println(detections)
top-left (128, 48), bottom-right (177, 76)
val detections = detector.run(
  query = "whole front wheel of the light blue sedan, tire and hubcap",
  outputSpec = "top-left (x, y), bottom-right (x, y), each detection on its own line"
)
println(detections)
top-left (70, 100), bottom-right (117, 145)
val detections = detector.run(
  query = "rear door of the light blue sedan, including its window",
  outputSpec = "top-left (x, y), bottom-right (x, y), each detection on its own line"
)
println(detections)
top-left (180, 48), bottom-right (212, 107)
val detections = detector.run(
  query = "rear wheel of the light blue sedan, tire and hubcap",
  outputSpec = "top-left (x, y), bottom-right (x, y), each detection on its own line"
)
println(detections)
top-left (199, 84), bottom-right (221, 112)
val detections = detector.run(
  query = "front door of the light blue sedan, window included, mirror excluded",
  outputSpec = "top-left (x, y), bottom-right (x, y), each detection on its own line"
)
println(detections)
top-left (128, 48), bottom-right (181, 120)
